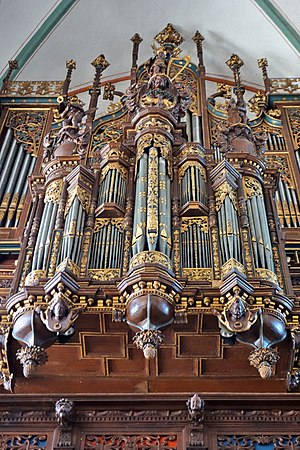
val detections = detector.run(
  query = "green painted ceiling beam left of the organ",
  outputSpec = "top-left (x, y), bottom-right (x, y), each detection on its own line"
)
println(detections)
top-left (0, 0), bottom-right (78, 86)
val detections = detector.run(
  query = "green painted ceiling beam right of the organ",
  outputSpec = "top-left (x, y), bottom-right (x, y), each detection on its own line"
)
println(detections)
top-left (254, 0), bottom-right (300, 53)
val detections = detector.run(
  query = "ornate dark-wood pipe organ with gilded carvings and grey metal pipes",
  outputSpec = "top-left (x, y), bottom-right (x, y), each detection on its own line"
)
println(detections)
top-left (0, 24), bottom-right (300, 449)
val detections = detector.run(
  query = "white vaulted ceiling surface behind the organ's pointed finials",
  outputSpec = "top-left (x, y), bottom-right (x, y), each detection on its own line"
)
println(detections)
top-left (0, 0), bottom-right (300, 95)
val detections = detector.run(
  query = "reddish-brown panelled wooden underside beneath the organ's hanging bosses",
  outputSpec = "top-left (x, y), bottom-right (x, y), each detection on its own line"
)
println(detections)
top-left (9, 312), bottom-right (288, 393)
